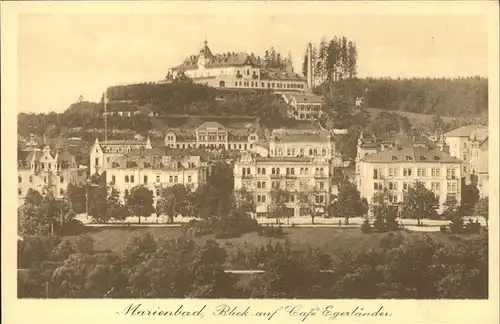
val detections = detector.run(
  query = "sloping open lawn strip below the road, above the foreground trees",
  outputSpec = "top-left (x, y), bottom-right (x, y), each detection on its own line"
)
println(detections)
top-left (64, 227), bottom-right (474, 254)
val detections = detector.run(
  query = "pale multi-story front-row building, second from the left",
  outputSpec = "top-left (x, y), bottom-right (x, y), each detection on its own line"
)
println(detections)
top-left (106, 148), bottom-right (208, 204)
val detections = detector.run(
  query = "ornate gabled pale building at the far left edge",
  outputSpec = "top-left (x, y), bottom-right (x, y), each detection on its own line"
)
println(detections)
top-left (17, 146), bottom-right (87, 199)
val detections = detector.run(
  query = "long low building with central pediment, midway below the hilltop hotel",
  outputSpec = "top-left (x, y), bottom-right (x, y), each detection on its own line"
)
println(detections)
top-left (165, 121), bottom-right (267, 155)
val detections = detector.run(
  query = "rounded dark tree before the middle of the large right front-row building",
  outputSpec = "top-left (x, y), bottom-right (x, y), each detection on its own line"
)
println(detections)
top-left (402, 181), bottom-right (438, 225)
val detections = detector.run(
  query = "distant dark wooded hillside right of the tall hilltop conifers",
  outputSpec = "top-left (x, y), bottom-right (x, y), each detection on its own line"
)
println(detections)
top-left (315, 77), bottom-right (488, 119)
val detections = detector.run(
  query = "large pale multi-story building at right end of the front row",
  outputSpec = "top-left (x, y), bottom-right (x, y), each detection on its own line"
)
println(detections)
top-left (356, 139), bottom-right (462, 211)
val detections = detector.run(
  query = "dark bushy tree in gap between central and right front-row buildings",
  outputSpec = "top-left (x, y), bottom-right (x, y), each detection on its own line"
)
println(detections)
top-left (333, 181), bottom-right (368, 224)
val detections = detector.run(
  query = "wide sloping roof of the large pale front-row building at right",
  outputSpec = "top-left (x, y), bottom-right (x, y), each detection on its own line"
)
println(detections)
top-left (361, 146), bottom-right (462, 163)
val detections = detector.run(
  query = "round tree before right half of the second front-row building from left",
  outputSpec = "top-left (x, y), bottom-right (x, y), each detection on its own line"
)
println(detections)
top-left (156, 184), bottom-right (190, 223)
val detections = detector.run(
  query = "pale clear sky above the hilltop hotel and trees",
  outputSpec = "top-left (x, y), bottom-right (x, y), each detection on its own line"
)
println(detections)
top-left (18, 12), bottom-right (488, 113)
